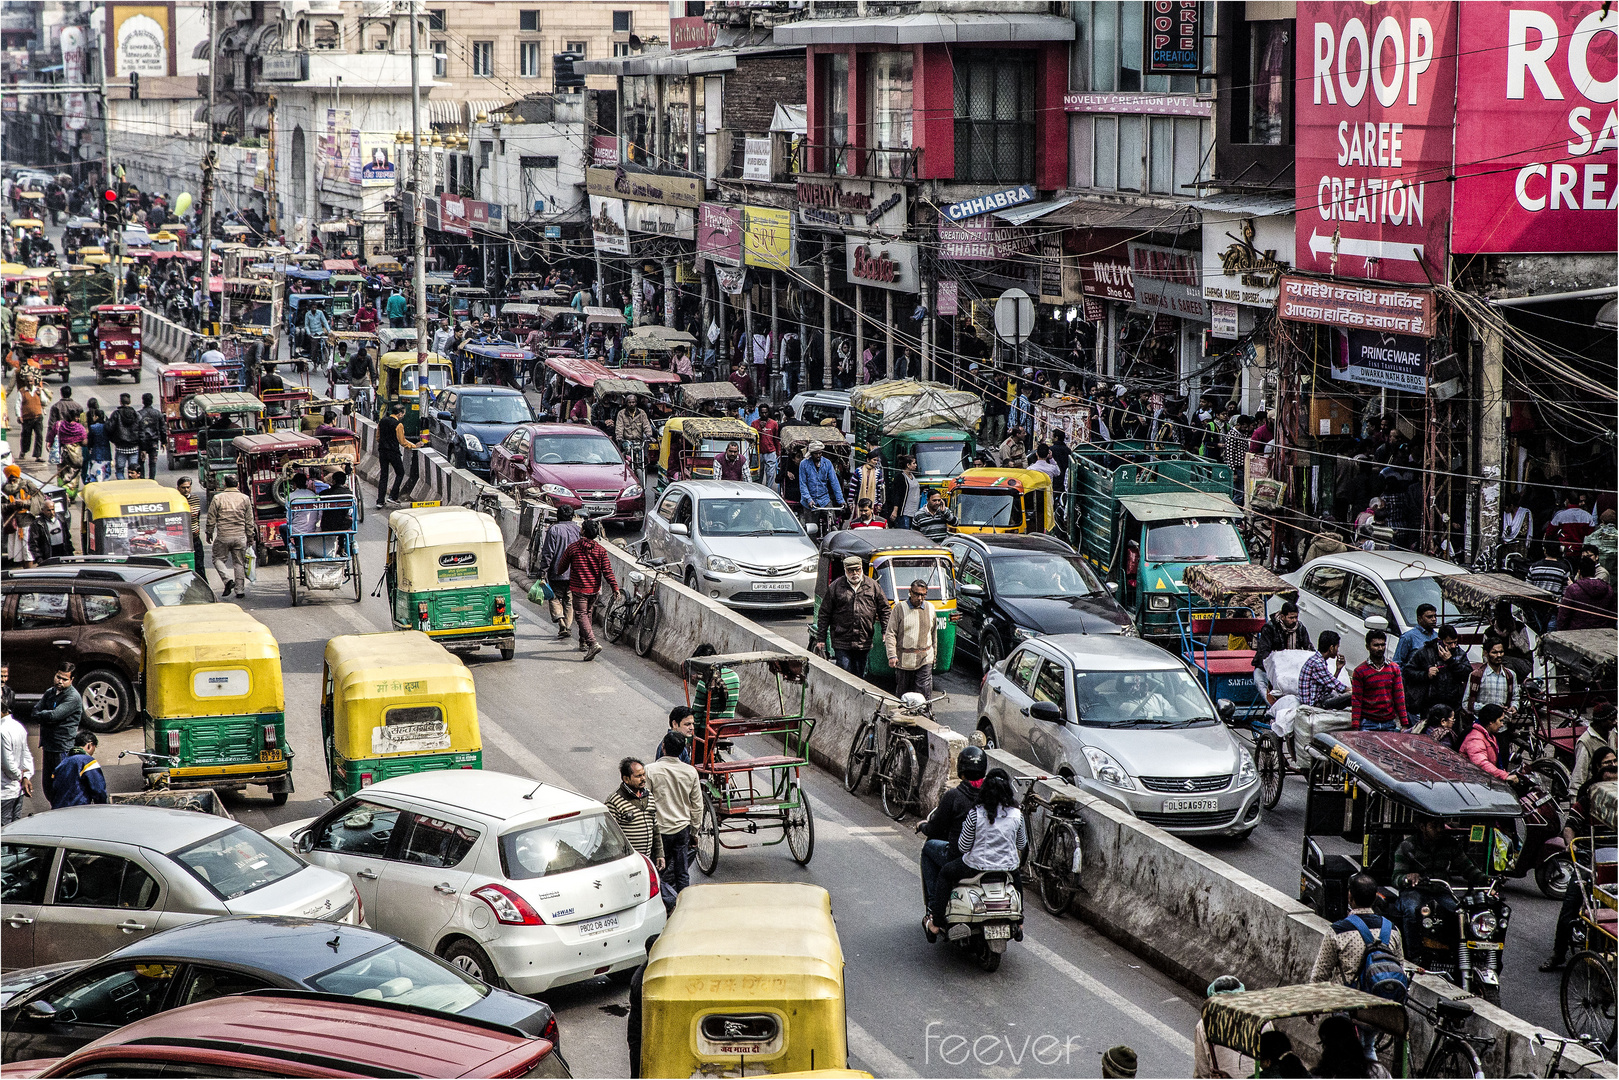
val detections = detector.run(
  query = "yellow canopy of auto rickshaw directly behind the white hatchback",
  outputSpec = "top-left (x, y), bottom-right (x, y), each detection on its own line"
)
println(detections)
top-left (324, 630), bottom-right (482, 759)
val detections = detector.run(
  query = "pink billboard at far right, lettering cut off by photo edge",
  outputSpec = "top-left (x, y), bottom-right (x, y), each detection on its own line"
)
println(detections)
top-left (1451, 0), bottom-right (1619, 253)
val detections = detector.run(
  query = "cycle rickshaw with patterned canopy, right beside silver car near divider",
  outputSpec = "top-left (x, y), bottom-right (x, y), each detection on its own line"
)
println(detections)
top-left (1175, 562), bottom-right (1308, 810)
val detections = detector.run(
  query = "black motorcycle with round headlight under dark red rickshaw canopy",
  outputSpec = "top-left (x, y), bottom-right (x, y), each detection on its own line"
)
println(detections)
top-left (1379, 878), bottom-right (1512, 1006)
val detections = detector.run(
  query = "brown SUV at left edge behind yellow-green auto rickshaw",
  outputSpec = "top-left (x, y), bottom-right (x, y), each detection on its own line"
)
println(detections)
top-left (0, 555), bottom-right (214, 732)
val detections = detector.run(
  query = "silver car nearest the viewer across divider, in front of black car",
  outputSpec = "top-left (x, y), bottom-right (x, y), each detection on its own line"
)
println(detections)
top-left (978, 635), bottom-right (1261, 837)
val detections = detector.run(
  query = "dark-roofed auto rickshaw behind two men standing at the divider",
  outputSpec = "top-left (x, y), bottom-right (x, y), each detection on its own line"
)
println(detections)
top-left (814, 529), bottom-right (955, 675)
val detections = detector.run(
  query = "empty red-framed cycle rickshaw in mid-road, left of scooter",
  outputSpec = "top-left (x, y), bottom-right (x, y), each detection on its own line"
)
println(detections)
top-left (685, 653), bottom-right (816, 874)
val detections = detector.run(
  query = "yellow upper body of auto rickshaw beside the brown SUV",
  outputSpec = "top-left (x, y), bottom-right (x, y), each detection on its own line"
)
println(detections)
top-left (144, 604), bottom-right (287, 719)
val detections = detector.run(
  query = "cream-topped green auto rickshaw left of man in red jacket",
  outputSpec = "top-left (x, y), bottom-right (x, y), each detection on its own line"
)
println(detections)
top-left (384, 507), bottom-right (516, 661)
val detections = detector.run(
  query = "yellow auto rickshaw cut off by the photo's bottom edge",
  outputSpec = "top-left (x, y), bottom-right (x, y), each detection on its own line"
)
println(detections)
top-left (630, 881), bottom-right (850, 1077)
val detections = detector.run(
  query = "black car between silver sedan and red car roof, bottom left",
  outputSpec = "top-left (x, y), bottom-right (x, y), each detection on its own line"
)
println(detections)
top-left (0, 915), bottom-right (557, 1062)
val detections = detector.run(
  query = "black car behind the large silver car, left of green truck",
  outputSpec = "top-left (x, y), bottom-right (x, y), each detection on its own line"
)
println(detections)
top-left (944, 533), bottom-right (1137, 670)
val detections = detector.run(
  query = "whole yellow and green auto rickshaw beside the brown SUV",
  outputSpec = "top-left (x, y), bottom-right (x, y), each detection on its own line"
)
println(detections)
top-left (141, 604), bottom-right (293, 806)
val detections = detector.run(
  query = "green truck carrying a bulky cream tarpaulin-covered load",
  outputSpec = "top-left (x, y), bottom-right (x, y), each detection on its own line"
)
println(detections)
top-left (848, 379), bottom-right (984, 489)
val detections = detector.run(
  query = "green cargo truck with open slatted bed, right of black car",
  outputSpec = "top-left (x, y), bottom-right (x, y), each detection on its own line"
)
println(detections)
top-left (1059, 440), bottom-right (1248, 638)
